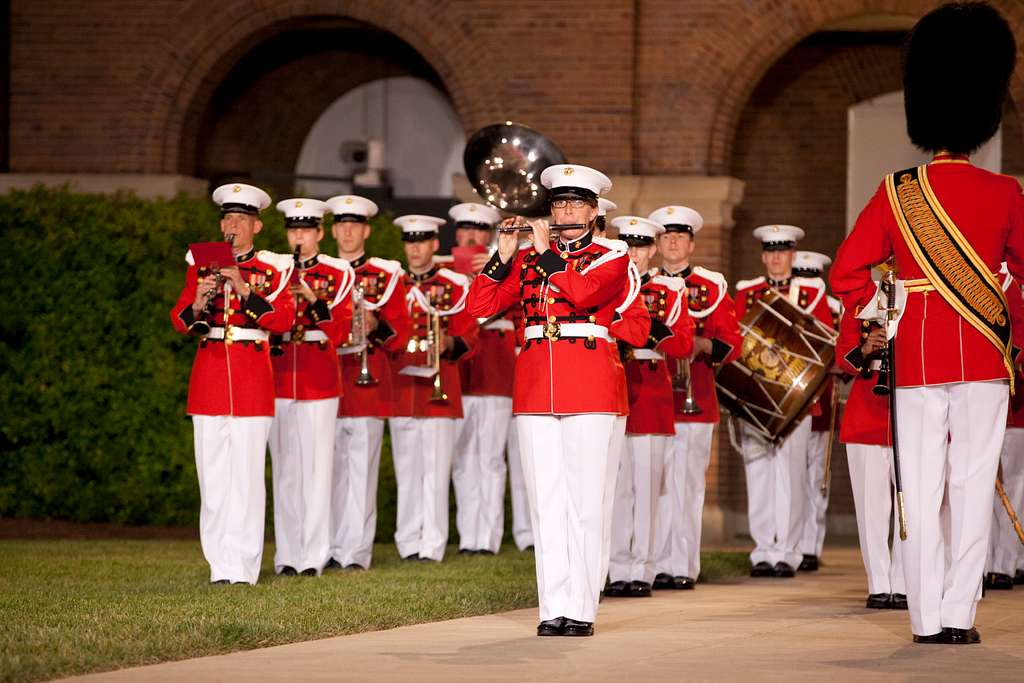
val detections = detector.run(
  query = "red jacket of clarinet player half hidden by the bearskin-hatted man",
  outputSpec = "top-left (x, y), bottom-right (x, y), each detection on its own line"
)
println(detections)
top-left (836, 307), bottom-right (892, 445)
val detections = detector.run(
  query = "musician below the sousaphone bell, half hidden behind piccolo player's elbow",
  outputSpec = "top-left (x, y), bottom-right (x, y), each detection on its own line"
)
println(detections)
top-left (449, 203), bottom-right (516, 555)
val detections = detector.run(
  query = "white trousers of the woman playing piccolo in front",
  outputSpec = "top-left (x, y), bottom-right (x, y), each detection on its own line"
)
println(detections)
top-left (516, 414), bottom-right (615, 622)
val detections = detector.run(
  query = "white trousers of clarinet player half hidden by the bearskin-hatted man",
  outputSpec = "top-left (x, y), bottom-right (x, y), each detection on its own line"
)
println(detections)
top-left (846, 443), bottom-right (906, 595)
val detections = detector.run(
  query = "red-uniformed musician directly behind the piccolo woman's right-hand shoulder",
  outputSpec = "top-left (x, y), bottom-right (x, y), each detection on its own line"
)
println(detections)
top-left (605, 216), bottom-right (693, 597)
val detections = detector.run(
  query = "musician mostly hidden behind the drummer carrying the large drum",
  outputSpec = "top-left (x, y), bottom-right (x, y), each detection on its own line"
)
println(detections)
top-left (793, 251), bottom-right (842, 571)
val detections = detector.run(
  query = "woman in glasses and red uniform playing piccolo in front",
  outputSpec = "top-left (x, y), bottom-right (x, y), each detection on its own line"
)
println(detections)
top-left (469, 164), bottom-right (629, 636)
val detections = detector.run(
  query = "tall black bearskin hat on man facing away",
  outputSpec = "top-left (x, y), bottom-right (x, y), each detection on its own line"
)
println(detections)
top-left (903, 2), bottom-right (1017, 154)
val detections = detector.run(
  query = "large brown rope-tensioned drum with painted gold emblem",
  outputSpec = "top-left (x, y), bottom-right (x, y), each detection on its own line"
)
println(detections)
top-left (716, 290), bottom-right (837, 443)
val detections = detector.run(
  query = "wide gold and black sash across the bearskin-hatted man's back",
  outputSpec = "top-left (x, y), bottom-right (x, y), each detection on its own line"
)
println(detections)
top-left (886, 165), bottom-right (1014, 391)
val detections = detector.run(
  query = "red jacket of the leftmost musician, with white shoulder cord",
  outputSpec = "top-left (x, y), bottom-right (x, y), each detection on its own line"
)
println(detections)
top-left (171, 250), bottom-right (295, 417)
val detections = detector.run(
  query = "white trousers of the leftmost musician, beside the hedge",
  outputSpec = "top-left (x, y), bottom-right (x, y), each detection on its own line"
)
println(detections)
top-left (193, 415), bottom-right (273, 584)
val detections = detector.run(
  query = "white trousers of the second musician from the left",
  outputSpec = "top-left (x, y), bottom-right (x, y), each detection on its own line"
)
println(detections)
top-left (270, 397), bottom-right (338, 574)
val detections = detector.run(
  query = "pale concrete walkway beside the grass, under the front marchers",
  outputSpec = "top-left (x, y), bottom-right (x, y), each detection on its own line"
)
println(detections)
top-left (64, 550), bottom-right (1024, 683)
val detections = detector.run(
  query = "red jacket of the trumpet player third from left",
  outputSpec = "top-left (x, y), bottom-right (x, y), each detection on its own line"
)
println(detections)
top-left (338, 256), bottom-right (413, 418)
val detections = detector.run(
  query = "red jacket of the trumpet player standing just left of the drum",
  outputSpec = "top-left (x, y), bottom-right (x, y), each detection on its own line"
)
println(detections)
top-left (662, 266), bottom-right (743, 423)
